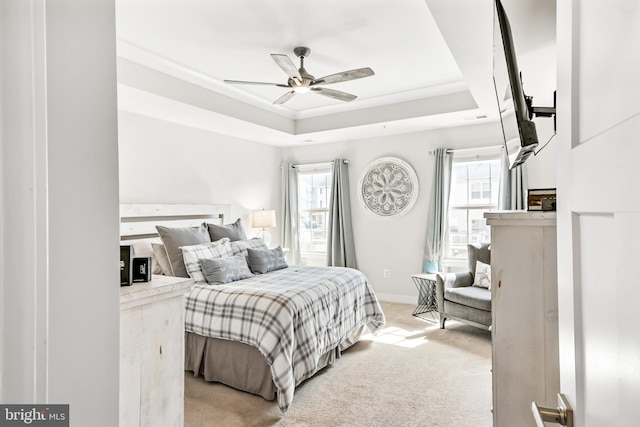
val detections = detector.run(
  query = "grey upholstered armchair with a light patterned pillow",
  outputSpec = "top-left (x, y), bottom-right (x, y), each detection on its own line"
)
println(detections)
top-left (436, 243), bottom-right (491, 330)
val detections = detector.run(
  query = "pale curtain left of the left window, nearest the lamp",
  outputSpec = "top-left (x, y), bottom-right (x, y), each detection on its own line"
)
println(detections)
top-left (280, 163), bottom-right (302, 265)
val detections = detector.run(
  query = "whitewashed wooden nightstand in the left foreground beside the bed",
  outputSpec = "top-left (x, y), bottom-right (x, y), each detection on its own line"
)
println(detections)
top-left (120, 276), bottom-right (193, 427)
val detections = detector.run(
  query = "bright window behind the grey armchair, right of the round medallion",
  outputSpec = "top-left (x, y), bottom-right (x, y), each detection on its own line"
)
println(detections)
top-left (445, 154), bottom-right (500, 259)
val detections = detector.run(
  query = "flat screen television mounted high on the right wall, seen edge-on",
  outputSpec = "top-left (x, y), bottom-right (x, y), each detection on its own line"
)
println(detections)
top-left (493, 0), bottom-right (538, 169)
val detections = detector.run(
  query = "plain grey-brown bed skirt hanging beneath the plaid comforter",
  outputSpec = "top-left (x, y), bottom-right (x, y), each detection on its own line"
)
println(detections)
top-left (184, 326), bottom-right (365, 400)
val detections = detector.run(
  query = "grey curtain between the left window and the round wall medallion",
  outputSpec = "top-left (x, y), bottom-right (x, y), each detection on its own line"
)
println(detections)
top-left (327, 159), bottom-right (356, 268)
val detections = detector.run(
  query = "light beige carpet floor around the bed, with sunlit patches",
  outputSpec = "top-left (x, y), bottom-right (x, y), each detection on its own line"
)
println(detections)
top-left (185, 302), bottom-right (492, 427)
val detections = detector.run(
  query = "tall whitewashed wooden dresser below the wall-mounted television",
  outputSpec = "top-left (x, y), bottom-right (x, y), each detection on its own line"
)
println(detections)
top-left (485, 211), bottom-right (560, 427)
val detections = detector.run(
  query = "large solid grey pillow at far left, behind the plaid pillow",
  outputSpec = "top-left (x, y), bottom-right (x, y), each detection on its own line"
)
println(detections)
top-left (156, 224), bottom-right (211, 277)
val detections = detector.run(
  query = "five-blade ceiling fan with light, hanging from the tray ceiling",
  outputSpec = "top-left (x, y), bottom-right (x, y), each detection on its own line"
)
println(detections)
top-left (225, 47), bottom-right (374, 104)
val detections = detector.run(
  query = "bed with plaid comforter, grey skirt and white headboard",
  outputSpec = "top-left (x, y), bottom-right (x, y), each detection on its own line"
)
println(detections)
top-left (121, 205), bottom-right (385, 412)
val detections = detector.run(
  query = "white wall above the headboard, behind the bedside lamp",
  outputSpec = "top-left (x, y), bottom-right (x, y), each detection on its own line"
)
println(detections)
top-left (118, 111), bottom-right (281, 245)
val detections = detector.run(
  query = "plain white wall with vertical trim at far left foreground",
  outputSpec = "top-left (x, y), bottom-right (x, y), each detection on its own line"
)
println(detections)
top-left (0, 0), bottom-right (119, 427)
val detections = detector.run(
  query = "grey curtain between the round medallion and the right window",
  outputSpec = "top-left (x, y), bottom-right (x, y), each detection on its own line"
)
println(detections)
top-left (422, 148), bottom-right (453, 271)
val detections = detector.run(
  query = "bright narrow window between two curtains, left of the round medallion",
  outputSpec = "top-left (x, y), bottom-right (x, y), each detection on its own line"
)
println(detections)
top-left (298, 163), bottom-right (331, 265)
